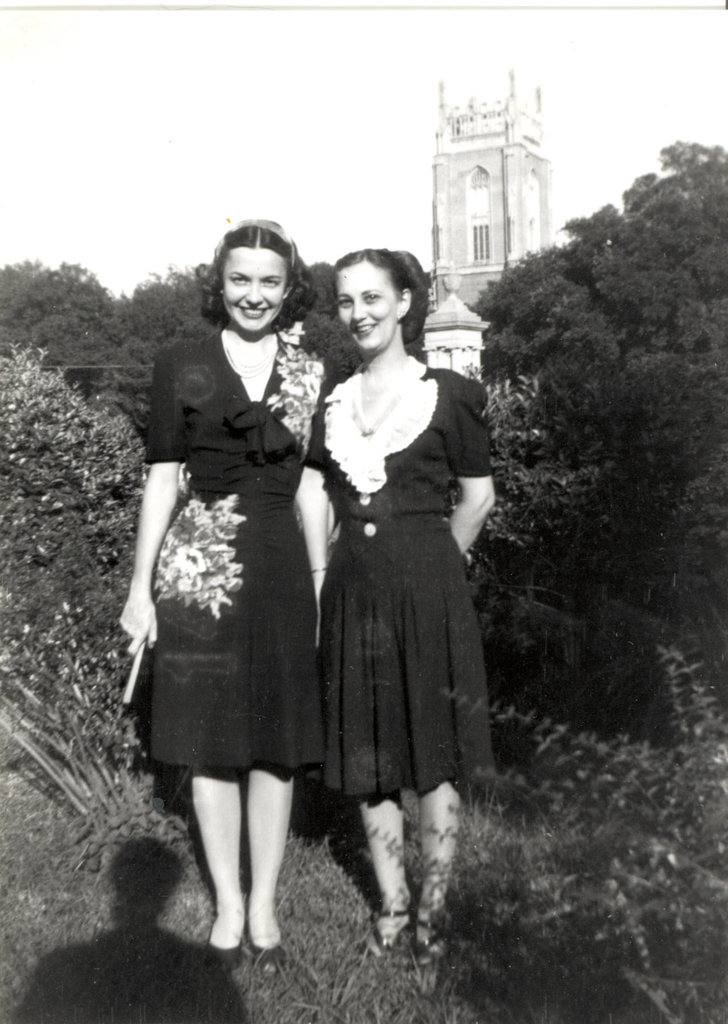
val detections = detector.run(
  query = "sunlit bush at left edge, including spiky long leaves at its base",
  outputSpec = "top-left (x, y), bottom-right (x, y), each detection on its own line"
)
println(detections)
top-left (0, 351), bottom-right (181, 858)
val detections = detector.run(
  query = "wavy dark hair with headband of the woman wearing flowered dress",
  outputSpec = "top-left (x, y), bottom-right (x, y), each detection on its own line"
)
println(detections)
top-left (197, 220), bottom-right (315, 331)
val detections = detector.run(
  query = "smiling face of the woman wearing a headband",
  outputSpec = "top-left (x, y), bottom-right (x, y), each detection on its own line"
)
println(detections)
top-left (222, 247), bottom-right (288, 341)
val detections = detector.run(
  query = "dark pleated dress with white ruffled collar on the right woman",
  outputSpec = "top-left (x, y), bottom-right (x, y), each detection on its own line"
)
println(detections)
top-left (308, 359), bottom-right (494, 796)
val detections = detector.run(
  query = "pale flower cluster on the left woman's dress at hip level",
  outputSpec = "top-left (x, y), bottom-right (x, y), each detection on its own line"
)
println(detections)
top-left (157, 495), bottom-right (246, 618)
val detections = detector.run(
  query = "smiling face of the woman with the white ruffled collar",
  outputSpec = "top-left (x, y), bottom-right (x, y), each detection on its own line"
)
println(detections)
top-left (336, 260), bottom-right (411, 358)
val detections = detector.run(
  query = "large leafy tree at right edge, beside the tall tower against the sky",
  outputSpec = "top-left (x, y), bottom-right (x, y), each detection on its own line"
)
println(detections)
top-left (477, 142), bottom-right (728, 374)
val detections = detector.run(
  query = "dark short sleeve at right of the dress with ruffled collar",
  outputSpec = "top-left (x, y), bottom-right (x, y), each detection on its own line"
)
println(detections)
top-left (445, 372), bottom-right (493, 476)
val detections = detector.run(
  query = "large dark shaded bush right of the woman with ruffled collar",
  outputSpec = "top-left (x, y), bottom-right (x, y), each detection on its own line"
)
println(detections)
top-left (471, 362), bottom-right (728, 738)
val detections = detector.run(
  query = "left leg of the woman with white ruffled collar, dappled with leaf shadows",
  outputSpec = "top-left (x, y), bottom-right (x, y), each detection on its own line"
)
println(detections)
top-left (360, 795), bottom-right (410, 946)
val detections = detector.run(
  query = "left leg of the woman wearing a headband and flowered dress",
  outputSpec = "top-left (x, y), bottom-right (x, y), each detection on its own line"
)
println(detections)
top-left (192, 769), bottom-right (245, 949)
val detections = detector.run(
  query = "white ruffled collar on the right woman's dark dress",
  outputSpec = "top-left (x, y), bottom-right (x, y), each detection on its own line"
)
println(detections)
top-left (326, 356), bottom-right (437, 495)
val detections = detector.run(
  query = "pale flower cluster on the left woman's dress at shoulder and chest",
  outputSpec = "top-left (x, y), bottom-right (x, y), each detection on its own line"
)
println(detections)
top-left (267, 331), bottom-right (324, 457)
